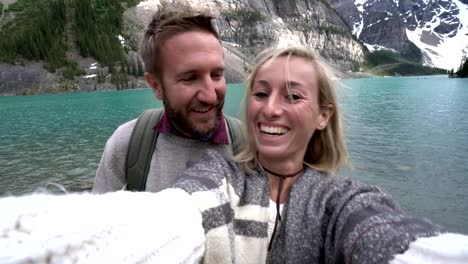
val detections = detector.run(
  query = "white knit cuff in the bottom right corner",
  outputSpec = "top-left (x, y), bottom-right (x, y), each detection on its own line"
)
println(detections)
top-left (390, 233), bottom-right (468, 264)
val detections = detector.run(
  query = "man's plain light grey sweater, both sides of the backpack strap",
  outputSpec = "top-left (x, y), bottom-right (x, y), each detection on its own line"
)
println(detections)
top-left (93, 119), bottom-right (232, 193)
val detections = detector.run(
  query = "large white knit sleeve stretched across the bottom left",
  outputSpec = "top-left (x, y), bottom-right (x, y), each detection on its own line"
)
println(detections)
top-left (0, 189), bottom-right (205, 263)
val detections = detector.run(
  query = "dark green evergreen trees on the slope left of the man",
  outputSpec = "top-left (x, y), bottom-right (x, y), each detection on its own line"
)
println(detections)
top-left (0, 0), bottom-right (143, 81)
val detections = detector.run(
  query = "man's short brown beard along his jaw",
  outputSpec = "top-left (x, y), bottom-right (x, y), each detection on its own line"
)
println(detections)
top-left (163, 94), bottom-right (224, 138)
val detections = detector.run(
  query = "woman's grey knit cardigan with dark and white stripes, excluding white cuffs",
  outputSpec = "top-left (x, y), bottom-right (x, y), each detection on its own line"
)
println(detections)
top-left (175, 151), bottom-right (439, 263)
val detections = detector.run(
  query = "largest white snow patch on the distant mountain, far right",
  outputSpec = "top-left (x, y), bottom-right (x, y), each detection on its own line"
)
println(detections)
top-left (406, 0), bottom-right (468, 70)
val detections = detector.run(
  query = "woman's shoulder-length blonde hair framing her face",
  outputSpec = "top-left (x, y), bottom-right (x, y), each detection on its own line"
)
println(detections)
top-left (235, 46), bottom-right (348, 173)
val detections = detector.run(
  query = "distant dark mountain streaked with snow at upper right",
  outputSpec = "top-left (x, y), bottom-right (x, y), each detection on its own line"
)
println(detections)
top-left (330, 0), bottom-right (468, 69)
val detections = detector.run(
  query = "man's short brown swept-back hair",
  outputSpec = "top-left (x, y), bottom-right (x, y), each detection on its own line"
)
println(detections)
top-left (140, 4), bottom-right (219, 78)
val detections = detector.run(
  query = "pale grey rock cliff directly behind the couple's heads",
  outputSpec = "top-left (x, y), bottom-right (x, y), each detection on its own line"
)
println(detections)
top-left (111, 0), bottom-right (365, 74)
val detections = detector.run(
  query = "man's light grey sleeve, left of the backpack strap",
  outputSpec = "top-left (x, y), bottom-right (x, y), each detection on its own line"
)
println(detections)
top-left (93, 120), bottom-right (136, 193)
